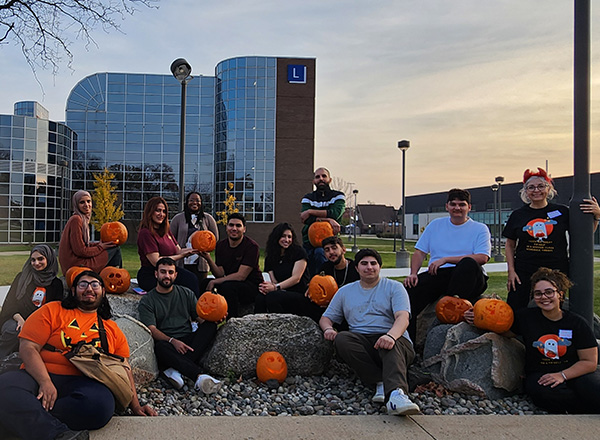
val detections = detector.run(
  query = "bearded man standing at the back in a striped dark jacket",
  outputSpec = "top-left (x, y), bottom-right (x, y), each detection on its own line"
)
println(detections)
top-left (300, 167), bottom-right (346, 276)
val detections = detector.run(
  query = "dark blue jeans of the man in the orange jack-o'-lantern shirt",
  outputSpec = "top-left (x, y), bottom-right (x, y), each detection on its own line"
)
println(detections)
top-left (0, 370), bottom-right (115, 440)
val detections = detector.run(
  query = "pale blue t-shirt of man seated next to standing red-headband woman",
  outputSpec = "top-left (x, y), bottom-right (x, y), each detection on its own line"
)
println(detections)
top-left (415, 217), bottom-right (492, 267)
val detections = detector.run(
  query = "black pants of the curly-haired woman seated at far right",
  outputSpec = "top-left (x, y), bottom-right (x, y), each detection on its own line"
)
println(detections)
top-left (525, 370), bottom-right (600, 414)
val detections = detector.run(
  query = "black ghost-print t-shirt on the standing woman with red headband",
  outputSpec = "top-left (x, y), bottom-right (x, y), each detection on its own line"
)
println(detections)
top-left (502, 203), bottom-right (569, 273)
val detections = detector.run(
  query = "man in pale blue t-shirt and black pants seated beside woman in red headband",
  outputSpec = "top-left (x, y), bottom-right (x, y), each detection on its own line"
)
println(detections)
top-left (404, 188), bottom-right (491, 340)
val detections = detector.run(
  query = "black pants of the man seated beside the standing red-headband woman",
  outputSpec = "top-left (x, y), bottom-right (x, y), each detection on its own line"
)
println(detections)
top-left (408, 257), bottom-right (487, 342)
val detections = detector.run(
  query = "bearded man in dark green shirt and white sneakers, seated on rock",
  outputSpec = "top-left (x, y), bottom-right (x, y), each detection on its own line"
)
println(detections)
top-left (138, 257), bottom-right (221, 394)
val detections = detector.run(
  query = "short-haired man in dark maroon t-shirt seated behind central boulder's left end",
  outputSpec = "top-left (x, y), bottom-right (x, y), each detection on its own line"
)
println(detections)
top-left (200, 212), bottom-right (263, 318)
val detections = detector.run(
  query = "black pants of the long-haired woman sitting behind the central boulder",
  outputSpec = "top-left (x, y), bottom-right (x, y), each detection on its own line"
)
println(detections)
top-left (254, 290), bottom-right (325, 323)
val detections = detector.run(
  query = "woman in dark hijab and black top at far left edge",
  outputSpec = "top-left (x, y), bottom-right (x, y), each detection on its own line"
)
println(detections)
top-left (0, 244), bottom-right (63, 359)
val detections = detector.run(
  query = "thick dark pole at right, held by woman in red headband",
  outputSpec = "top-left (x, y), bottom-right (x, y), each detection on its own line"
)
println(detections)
top-left (569, 0), bottom-right (594, 325)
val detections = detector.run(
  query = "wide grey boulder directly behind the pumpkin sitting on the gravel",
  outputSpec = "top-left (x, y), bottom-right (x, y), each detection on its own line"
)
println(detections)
top-left (204, 314), bottom-right (333, 378)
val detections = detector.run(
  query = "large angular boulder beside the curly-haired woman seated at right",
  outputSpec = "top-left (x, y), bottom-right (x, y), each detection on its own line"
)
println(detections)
top-left (422, 322), bottom-right (525, 399)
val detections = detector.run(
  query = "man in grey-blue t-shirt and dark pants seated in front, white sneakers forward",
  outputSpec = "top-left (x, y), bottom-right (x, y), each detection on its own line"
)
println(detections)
top-left (319, 249), bottom-right (420, 415)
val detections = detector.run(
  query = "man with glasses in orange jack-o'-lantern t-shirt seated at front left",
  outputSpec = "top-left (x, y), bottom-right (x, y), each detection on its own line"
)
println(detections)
top-left (0, 271), bottom-right (157, 440)
